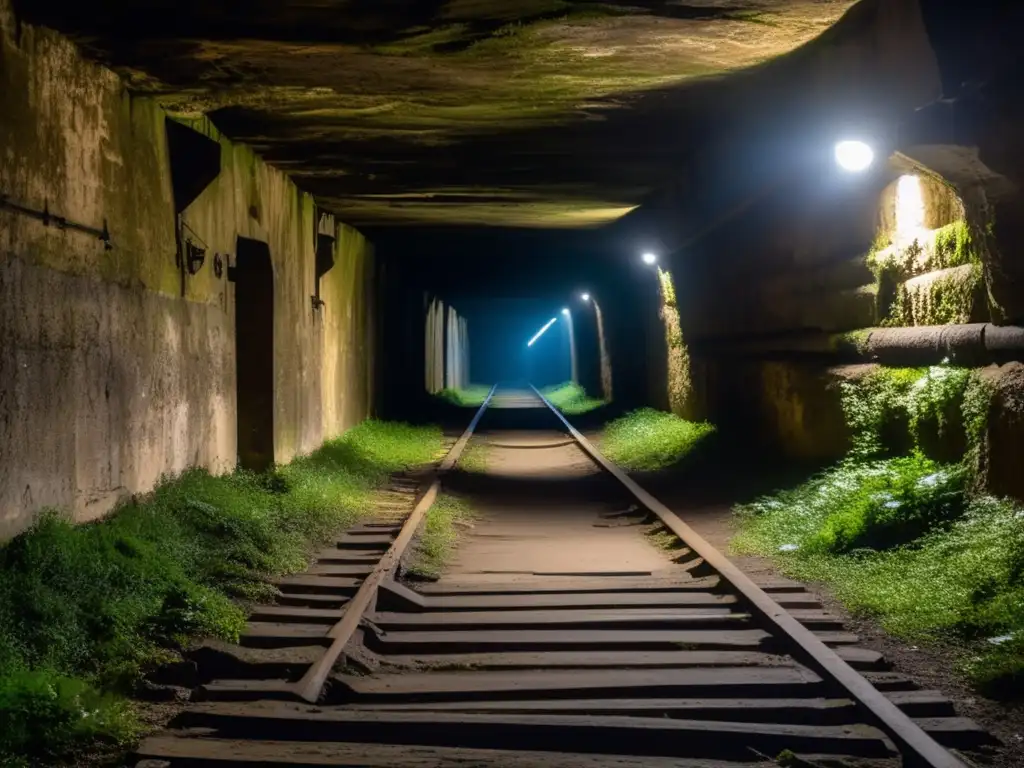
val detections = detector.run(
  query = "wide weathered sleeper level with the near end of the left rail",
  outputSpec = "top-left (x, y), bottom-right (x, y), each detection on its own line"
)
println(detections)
top-left (331, 667), bottom-right (823, 702)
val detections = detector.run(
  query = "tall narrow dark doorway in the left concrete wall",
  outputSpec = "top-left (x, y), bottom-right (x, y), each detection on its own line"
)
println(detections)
top-left (232, 238), bottom-right (273, 471)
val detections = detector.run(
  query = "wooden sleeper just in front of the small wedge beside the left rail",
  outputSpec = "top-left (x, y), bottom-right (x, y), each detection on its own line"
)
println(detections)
top-left (369, 607), bottom-right (750, 632)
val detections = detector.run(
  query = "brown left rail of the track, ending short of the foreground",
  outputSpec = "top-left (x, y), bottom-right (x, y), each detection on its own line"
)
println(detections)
top-left (296, 385), bottom-right (497, 701)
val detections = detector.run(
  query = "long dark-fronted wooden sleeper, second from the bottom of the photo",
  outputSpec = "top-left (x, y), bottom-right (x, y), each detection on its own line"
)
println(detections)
top-left (176, 701), bottom-right (891, 765)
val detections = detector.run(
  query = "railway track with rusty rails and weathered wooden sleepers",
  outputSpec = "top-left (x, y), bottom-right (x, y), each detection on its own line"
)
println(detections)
top-left (136, 389), bottom-right (988, 768)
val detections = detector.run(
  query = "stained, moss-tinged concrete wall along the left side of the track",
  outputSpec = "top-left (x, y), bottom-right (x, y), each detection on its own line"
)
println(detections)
top-left (0, 0), bottom-right (373, 538)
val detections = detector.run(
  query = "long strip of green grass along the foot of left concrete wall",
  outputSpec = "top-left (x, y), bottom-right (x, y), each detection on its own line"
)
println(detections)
top-left (0, 421), bottom-right (441, 766)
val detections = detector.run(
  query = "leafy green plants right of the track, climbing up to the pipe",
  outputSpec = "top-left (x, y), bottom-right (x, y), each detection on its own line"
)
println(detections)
top-left (733, 366), bottom-right (1024, 697)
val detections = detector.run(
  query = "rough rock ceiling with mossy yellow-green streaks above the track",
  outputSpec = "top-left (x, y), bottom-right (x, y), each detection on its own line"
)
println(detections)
top-left (20, 0), bottom-right (854, 227)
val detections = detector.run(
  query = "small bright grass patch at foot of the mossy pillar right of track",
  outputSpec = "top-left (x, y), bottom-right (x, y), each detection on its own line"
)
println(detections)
top-left (600, 408), bottom-right (715, 470)
